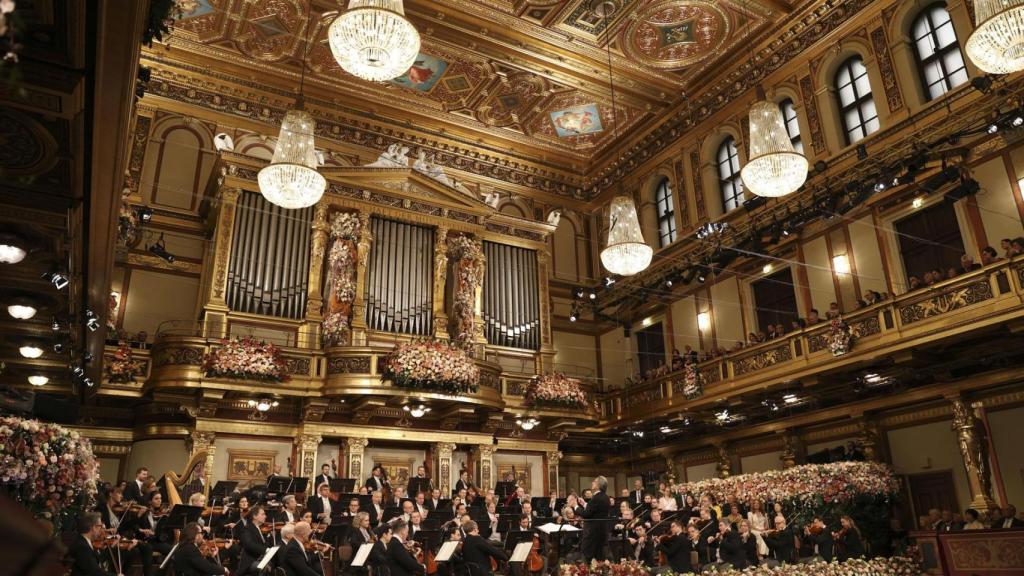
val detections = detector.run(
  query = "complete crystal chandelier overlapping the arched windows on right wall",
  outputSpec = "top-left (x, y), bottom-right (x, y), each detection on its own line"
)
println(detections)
top-left (739, 100), bottom-right (807, 198)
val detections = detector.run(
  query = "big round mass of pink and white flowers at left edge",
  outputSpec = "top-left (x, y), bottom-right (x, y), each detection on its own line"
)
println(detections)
top-left (0, 416), bottom-right (98, 528)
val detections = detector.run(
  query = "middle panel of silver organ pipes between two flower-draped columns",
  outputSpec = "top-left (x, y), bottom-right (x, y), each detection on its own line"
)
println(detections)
top-left (367, 216), bottom-right (434, 336)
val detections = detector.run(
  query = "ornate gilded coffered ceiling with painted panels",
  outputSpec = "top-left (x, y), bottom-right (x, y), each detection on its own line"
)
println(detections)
top-left (161, 0), bottom-right (791, 166)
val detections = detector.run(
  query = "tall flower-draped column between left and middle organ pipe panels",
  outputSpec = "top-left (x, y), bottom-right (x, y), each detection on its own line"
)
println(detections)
top-left (323, 212), bottom-right (359, 345)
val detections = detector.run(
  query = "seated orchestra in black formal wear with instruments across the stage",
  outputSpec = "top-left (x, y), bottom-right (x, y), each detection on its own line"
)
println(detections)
top-left (69, 461), bottom-right (888, 576)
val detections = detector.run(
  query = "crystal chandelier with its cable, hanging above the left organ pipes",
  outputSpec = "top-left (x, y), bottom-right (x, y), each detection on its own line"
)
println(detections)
top-left (256, 3), bottom-right (327, 209)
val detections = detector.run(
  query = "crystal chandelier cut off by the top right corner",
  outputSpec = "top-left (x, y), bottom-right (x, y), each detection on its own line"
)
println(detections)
top-left (964, 0), bottom-right (1024, 74)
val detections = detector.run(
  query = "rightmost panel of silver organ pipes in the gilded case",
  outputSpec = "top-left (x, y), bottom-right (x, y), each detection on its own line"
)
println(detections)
top-left (483, 242), bottom-right (541, 349)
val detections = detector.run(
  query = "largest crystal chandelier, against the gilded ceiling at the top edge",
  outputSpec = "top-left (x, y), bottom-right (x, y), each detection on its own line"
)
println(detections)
top-left (328, 0), bottom-right (420, 82)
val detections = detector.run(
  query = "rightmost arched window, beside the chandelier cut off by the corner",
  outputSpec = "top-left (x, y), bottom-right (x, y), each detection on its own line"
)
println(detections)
top-left (910, 4), bottom-right (968, 100)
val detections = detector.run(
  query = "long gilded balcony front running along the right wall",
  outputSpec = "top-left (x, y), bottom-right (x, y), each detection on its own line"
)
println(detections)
top-left (599, 256), bottom-right (1024, 424)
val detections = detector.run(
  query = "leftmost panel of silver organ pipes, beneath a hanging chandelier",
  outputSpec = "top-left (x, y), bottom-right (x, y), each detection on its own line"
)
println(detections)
top-left (226, 192), bottom-right (313, 319)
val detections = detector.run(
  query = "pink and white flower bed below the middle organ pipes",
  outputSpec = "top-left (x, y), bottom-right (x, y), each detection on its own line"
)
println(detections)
top-left (381, 340), bottom-right (480, 395)
